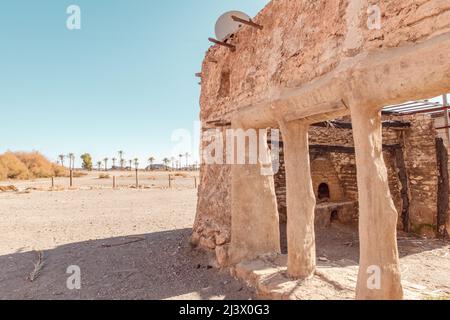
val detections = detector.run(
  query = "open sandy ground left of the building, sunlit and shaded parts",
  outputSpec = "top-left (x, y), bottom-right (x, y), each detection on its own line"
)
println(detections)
top-left (0, 173), bottom-right (252, 299)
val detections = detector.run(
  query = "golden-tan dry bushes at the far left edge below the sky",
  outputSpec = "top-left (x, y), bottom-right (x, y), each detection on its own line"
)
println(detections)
top-left (0, 151), bottom-right (68, 180)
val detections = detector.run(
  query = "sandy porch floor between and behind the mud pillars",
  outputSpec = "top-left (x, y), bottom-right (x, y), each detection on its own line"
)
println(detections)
top-left (281, 223), bottom-right (450, 300)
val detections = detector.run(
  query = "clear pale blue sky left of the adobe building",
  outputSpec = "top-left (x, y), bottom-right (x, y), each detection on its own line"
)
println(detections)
top-left (0, 0), bottom-right (268, 168)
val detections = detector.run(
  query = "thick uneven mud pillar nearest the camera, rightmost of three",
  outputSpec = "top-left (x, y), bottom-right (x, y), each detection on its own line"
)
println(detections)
top-left (351, 105), bottom-right (403, 300)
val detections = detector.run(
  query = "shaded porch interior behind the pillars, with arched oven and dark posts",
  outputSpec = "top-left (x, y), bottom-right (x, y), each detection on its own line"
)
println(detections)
top-left (275, 111), bottom-right (450, 237)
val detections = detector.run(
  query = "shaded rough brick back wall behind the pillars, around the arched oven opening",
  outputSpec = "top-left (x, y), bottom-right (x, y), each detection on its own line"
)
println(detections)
top-left (275, 115), bottom-right (438, 236)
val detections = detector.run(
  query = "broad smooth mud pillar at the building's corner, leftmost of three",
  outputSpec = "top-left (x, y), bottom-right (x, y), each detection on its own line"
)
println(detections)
top-left (227, 126), bottom-right (281, 264)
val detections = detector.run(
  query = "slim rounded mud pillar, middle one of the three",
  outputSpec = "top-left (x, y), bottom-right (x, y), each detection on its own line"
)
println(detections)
top-left (280, 121), bottom-right (316, 279)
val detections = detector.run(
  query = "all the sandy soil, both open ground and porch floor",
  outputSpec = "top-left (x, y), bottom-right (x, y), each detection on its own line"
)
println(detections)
top-left (0, 172), bottom-right (450, 299)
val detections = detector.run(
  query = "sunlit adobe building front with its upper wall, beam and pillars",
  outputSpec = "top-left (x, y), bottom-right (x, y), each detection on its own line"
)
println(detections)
top-left (192, 0), bottom-right (450, 299)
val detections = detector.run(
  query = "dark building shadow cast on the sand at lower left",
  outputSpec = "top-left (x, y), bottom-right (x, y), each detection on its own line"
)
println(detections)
top-left (0, 229), bottom-right (252, 300)
